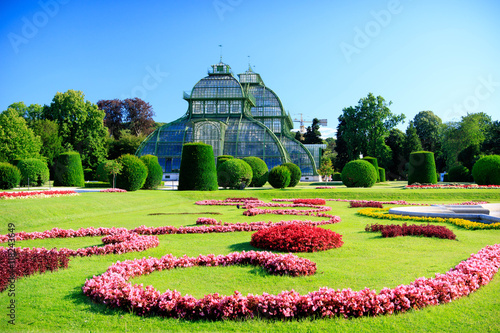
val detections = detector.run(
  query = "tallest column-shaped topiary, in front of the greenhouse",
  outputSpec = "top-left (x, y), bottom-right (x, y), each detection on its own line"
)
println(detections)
top-left (178, 142), bottom-right (218, 191)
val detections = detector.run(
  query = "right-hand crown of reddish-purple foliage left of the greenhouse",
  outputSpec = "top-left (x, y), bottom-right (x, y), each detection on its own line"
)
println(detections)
top-left (123, 97), bottom-right (155, 136)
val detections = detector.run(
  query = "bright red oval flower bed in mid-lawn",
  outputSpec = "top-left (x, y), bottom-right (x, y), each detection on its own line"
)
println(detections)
top-left (250, 224), bottom-right (344, 252)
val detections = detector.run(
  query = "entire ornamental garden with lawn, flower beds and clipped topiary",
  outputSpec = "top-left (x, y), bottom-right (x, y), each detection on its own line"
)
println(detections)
top-left (0, 147), bottom-right (500, 332)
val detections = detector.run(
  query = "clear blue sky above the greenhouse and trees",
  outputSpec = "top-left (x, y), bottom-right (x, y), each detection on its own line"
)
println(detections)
top-left (0, 0), bottom-right (500, 137)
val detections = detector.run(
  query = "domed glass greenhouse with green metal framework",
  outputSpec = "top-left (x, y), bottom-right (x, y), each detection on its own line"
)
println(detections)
top-left (136, 62), bottom-right (324, 180)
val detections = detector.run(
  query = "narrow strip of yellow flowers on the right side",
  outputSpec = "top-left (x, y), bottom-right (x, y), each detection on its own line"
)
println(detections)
top-left (358, 208), bottom-right (500, 230)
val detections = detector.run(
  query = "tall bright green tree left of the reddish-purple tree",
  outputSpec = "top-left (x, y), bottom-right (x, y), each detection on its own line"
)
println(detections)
top-left (44, 90), bottom-right (108, 170)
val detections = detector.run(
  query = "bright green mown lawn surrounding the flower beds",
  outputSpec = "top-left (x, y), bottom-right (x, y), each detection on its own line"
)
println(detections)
top-left (0, 183), bottom-right (500, 332)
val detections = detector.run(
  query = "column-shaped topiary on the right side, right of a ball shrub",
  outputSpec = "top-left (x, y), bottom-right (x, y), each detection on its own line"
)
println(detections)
top-left (408, 151), bottom-right (437, 185)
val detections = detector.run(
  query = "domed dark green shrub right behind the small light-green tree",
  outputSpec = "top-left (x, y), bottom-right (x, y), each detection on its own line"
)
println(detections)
top-left (116, 154), bottom-right (148, 191)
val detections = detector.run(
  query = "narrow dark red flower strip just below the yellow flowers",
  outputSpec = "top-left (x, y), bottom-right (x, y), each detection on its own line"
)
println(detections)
top-left (365, 223), bottom-right (457, 239)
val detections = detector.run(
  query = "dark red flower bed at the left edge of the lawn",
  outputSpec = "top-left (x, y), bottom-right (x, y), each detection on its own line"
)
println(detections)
top-left (0, 247), bottom-right (69, 292)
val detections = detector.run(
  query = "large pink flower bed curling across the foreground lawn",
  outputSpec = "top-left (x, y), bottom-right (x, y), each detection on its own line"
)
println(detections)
top-left (83, 244), bottom-right (500, 320)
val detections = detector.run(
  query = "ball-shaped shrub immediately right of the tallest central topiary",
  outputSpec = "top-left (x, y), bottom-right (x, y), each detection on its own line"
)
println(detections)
top-left (217, 158), bottom-right (253, 190)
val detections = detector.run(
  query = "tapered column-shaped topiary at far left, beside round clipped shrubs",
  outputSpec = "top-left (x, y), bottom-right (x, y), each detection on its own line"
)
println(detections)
top-left (54, 151), bottom-right (85, 186)
